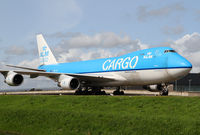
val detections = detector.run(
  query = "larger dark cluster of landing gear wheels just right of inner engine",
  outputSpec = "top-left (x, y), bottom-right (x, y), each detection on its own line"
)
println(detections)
top-left (74, 87), bottom-right (107, 95)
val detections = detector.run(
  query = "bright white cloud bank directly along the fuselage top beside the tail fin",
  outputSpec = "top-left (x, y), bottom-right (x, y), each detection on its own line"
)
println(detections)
top-left (58, 40), bottom-right (148, 62)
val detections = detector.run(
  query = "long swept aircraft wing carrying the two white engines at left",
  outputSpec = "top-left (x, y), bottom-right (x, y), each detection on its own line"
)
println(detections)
top-left (0, 70), bottom-right (115, 82)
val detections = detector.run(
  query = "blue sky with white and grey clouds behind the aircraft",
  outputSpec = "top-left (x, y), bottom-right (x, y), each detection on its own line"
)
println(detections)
top-left (0, 0), bottom-right (200, 88)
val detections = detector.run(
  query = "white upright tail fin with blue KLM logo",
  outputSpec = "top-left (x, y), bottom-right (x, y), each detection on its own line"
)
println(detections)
top-left (37, 34), bottom-right (57, 65)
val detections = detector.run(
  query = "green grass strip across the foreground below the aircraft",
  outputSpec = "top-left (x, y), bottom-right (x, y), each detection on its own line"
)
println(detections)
top-left (0, 96), bottom-right (200, 135)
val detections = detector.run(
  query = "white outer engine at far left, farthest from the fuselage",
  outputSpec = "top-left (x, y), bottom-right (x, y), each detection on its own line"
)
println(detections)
top-left (5, 71), bottom-right (24, 86)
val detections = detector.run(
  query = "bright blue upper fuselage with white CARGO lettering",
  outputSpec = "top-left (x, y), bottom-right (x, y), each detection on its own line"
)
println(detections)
top-left (39, 47), bottom-right (192, 74)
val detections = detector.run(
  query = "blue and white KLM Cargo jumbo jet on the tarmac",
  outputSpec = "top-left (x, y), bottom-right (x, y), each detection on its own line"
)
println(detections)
top-left (0, 34), bottom-right (192, 95)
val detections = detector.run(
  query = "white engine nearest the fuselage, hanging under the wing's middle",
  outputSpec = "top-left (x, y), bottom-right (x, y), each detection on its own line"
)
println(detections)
top-left (58, 75), bottom-right (80, 90)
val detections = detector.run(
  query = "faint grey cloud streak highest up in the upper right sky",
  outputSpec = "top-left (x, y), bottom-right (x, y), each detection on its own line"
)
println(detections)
top-left (137, 3), bottom-right (185, 21)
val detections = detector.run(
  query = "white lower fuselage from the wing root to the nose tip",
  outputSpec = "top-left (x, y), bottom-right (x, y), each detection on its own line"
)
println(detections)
top-left (110, 68), bottom-right (191, 85)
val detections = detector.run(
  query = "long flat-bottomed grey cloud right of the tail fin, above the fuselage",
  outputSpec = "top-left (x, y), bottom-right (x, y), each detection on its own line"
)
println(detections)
top-left (59, 32), bottom-right (137, 48)
